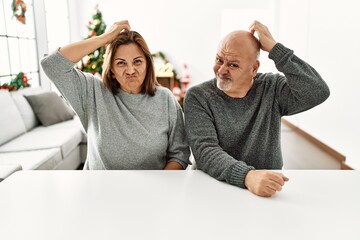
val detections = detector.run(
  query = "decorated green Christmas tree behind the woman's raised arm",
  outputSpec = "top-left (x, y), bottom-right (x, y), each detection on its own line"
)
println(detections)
top-left (79, 6), bottom-right (106, 75)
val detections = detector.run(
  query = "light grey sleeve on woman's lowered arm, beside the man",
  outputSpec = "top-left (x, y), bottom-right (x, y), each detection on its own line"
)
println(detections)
top-left (167, 94), bottom-right (190, 169)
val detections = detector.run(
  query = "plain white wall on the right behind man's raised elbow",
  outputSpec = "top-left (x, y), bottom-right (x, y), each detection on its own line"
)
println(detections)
top-left (279, 0), bottom-right (360, 169)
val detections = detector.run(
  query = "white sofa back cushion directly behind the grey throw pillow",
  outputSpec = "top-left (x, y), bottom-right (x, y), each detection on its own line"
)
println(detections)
top-left (10, 88), bottom-right (46, 131)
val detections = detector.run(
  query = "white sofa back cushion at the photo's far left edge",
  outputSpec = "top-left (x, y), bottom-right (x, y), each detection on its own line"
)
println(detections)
top-left (0, 90), bottom-right (26, 145)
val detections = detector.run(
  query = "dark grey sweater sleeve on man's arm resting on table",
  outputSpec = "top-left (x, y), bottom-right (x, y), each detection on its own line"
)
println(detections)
top-left (184, 88), bottom-right (255, 188)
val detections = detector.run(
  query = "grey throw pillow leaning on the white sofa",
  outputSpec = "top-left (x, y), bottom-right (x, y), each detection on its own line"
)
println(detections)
top-left (24, 92), bottom-right (75, 127)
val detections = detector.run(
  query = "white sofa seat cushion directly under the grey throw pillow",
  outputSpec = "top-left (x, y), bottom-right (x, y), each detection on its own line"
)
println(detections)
top-left (0, 128), bottom-right (81, 158)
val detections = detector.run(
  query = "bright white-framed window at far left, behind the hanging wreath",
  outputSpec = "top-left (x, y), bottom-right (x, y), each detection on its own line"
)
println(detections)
top-left (0, 0), bottom-right (39, 87)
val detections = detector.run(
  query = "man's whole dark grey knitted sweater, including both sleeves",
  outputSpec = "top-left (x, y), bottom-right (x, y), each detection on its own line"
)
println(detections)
top-left (184, 43), bottom-right (330, 188)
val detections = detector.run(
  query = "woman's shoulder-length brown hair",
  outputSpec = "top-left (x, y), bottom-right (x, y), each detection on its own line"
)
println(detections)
top-left (102, 31), bottom-right (159, 96)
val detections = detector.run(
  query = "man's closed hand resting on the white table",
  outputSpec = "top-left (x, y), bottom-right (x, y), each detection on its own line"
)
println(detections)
top-left (245, 170), bottom-right (289, 197)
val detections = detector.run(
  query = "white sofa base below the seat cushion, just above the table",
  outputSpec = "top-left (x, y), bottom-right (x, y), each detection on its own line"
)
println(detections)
top-left (0, 148), bottom-right (62, 170)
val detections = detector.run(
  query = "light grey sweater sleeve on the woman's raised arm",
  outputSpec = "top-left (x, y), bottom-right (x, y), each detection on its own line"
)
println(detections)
top-left (41, 51), bottom-right (94, 130)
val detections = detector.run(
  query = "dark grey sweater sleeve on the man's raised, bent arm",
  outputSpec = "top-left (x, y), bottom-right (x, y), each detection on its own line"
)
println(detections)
top-left (269, 43), bottom-right (330, 116)
